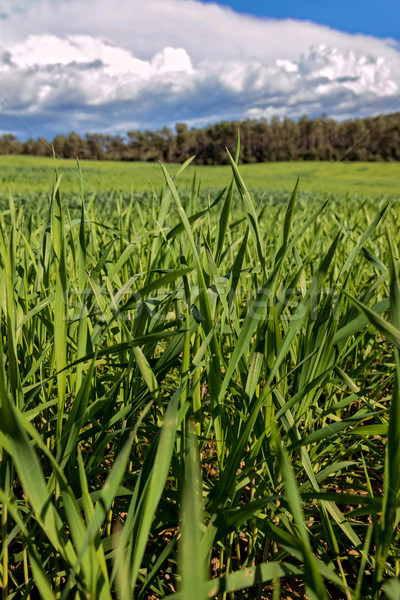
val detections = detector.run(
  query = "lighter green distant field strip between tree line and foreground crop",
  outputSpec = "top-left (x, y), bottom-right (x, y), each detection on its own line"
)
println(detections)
top-left (0, 156), bottom-right (400, 197)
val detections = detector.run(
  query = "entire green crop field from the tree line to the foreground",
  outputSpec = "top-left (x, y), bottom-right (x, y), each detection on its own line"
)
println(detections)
top-left (0, 151), bottom-right (400, 600)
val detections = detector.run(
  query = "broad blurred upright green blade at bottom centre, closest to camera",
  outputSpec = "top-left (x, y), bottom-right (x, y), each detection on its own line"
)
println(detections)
top-left (179, 423), bottom-right (207, 600)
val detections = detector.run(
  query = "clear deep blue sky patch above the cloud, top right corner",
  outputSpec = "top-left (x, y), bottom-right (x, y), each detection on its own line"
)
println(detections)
top-left (203, 0), bottom-right (400, 40)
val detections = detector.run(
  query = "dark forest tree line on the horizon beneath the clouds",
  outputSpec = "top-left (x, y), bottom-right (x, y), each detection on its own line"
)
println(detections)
top-left (0, 112), bottom-right (400, 165)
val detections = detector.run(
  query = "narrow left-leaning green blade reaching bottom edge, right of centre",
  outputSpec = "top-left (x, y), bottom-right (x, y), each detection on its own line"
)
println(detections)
top-left (271, 423), bottom-right (328, 600)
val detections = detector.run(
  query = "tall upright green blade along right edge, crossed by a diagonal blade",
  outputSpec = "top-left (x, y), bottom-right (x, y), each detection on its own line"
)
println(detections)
top-left (376, 233), bottom-right (400, 585)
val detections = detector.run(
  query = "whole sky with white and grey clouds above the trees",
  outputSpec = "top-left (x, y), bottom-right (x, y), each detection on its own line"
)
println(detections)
top-left (0, 0), bottom-right (400, 139)
